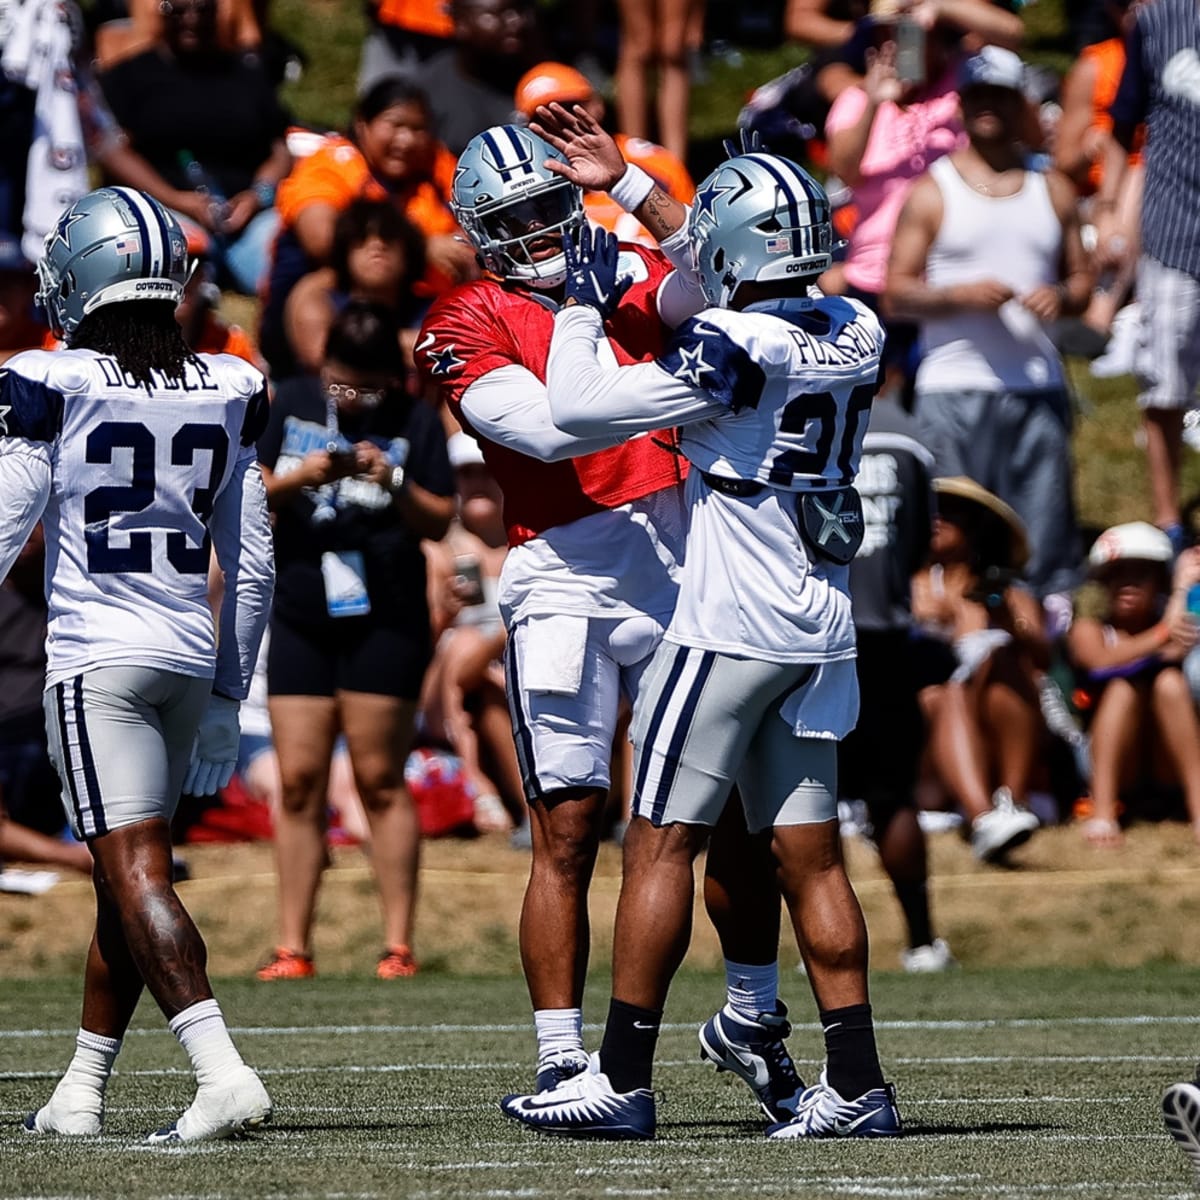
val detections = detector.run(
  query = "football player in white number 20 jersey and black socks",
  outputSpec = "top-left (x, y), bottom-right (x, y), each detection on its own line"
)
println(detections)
top-left (503, 108), bottom-right (900, 1140)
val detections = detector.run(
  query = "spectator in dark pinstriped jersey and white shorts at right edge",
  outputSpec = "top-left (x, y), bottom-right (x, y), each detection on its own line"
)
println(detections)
top-left (1097, 0), bottom-right (1200, 548)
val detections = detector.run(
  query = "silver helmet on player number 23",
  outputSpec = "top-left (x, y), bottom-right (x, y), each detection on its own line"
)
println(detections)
top-left (37, 187), bottom-right (188, 346)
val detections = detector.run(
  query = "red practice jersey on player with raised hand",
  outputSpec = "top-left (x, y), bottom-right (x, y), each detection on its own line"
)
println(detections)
top-left (416, 245), bottom-right (685, 546)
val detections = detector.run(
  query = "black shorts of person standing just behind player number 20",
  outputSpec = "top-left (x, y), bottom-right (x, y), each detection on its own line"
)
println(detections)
top-left (838, 630), bottom-right (925, 834)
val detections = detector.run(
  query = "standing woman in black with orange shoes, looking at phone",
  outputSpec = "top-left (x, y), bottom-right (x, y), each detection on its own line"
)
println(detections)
top-left (259, 301), bottom-right (454, 979)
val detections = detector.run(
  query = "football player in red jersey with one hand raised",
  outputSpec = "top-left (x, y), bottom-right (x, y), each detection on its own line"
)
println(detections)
top-left (416, 125), bottom-right (800, 1123)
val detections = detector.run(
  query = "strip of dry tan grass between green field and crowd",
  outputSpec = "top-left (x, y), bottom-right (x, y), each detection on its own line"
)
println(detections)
top-left (0, 824), bottom-right (1200, 978)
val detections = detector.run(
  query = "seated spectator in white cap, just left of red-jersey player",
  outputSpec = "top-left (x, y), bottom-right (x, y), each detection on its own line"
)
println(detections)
top-left (421, 433), bottom-right (524, 833)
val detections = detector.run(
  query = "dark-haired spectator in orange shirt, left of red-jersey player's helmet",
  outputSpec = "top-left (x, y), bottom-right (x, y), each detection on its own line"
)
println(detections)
top-left (259, 77), bottom-right (478, 379)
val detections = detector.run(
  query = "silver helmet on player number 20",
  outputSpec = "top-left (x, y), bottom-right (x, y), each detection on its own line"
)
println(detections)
top-left (690, 154), bottom-right (833, 308)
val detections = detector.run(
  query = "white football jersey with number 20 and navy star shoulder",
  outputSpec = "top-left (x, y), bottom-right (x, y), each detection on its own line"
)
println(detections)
top-left (548, 296), bottom-right (883, 662)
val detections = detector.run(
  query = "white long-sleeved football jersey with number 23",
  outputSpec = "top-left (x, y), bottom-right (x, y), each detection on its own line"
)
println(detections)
top-left (0, 349), bottom-right (274, 698)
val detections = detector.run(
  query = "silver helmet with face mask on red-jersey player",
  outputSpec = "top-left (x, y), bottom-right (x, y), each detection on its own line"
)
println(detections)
top-left (450, 125), bottom-right (583, 288)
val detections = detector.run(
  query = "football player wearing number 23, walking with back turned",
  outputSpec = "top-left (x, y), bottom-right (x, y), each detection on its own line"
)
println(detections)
top-left (0, 187), bottom-right (275, 1142)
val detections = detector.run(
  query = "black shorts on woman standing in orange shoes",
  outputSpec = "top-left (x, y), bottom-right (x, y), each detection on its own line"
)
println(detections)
top-left (266, 616), bottom-right (432, 700)
